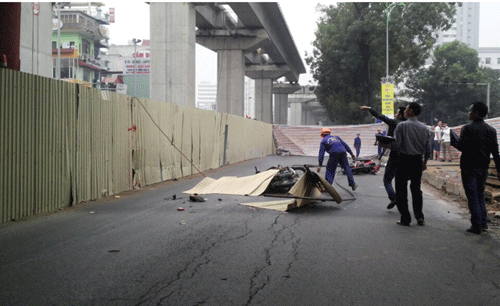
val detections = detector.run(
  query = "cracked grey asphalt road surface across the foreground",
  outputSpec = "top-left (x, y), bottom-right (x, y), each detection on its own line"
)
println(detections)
top-left (0, 156), bottom-right (500, 306)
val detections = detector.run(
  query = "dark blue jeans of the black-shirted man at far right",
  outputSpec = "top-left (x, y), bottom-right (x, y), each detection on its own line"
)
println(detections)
top-left (462, 169), bottom-right (488, 230)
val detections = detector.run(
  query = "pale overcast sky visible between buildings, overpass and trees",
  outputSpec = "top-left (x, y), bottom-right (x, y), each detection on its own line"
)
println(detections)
top-left (104, 0), bottom-right (500, 85)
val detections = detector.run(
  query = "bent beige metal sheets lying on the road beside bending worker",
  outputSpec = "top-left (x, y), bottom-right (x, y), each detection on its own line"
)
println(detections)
top-left (184, 169), bottom-right (342, 211)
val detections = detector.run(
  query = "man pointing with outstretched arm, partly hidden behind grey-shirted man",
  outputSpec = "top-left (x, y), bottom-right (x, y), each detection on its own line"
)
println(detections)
top-left (359, 106), bottom-right (405, 209)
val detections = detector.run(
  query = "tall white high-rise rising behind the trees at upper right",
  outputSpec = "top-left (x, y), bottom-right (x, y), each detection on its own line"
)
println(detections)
top-left (437, 2), bottom-right (479, 50)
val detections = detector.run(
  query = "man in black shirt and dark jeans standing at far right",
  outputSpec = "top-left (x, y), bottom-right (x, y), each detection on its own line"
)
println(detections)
top-left (452, 102), bottom-right (500, 234)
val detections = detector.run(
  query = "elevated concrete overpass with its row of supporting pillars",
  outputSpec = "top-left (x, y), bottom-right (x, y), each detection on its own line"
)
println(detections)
top-left (150, 2), bottom-right (306, 124)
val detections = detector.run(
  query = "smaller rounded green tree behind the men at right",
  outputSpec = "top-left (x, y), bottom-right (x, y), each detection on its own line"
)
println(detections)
top-left (405, 41), bottom-right (499, 126)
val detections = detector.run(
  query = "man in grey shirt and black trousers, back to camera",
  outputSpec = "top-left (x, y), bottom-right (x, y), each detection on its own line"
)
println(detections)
top-left (394, 102), bottom-right (431, 226)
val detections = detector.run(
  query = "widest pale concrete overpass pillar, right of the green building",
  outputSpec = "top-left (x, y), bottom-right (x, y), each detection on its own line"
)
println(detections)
top-left (150, 2), bottom-right (196, 107)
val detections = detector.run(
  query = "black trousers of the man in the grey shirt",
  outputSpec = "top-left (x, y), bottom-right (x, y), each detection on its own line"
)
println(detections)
top-left (396, 154), bottom-right (424, 223)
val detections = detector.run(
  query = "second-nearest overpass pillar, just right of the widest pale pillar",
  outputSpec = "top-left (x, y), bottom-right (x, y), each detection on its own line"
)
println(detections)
top-left (217, 50), bottom-right (245, 117)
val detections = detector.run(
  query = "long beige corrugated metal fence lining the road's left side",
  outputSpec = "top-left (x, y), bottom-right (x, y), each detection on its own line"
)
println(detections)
top-left (0, 69), bottom-right (274, 223)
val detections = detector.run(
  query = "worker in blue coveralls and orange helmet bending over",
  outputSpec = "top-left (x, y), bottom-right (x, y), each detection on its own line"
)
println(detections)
top-left (317, 128), bottom-right (358, 190)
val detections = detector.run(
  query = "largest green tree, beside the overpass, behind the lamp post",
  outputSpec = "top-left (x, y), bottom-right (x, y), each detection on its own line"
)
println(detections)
top-left (306, 2), bottom-right (455, 124)
